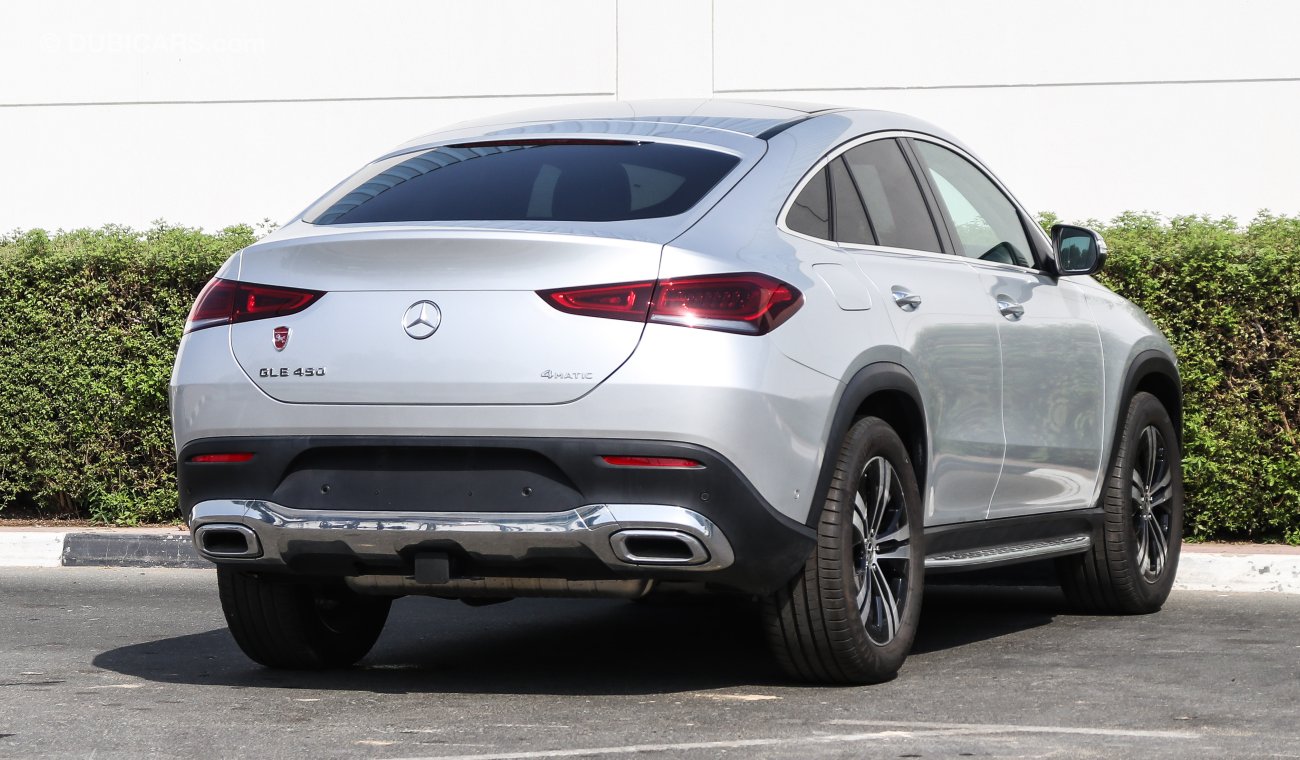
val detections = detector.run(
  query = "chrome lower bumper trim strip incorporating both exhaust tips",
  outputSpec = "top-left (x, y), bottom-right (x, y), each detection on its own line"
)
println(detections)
top-left (191, 500), bottom-right (735, 576)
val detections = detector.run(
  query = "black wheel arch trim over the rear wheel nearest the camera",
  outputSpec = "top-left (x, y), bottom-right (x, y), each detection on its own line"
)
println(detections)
top-left (805, 361), bottom-right (930, 527)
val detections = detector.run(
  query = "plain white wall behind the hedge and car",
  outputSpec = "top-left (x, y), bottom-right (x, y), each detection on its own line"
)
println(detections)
top-left (0, 0), bottom-right (1300, 230)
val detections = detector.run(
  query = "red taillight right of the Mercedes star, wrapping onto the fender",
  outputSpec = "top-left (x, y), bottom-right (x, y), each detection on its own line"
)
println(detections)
top-left (537, 273), bottom-right (803, 335)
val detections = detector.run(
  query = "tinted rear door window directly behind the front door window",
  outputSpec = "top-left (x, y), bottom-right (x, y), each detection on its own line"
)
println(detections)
top-left (844, 140), bottom-right (943, 252)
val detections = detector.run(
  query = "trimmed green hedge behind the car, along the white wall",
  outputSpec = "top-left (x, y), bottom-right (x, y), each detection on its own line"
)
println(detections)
top-left (0, 214), bottom-right (1300, 543)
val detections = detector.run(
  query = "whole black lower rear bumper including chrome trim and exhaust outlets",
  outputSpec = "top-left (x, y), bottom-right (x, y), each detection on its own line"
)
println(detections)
top-left (179, 437), bottom-right (814, 596)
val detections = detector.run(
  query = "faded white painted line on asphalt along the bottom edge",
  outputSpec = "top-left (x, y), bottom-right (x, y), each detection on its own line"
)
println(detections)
top-left (387, 720), bottom-right (1200, 760)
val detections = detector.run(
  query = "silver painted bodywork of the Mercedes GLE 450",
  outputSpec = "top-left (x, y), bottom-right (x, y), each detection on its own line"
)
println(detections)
top-left (170, 101), bottom-right (1173, 540)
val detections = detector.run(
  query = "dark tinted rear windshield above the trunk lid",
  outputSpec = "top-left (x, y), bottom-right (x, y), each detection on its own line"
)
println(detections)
top-left (297, 140), bottom-right (740, 225)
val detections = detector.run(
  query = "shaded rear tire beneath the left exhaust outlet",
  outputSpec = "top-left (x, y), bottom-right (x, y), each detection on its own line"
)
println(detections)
top-left (217, 566), bottom-right (391, 670)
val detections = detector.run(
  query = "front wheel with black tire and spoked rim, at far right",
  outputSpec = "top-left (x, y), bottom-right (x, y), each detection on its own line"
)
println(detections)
top-left (1058, 394), bottom-right (1183, 613)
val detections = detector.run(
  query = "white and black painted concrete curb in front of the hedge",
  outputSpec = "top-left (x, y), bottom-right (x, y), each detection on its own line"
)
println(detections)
top-left (0, 527), bottom-right (1300, 594)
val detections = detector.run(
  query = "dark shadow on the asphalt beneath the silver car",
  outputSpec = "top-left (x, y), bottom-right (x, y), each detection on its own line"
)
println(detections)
top-left (94, 587), bottom-right (1065, 695)
